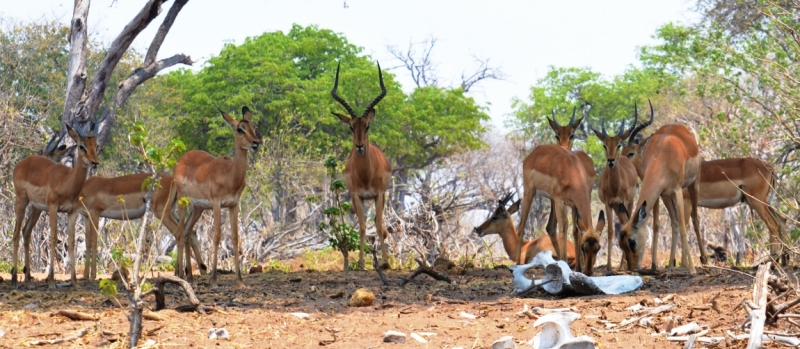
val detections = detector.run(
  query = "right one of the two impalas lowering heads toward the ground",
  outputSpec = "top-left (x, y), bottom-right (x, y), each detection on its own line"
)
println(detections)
top-left (620, 103), bottom-right (705, 274)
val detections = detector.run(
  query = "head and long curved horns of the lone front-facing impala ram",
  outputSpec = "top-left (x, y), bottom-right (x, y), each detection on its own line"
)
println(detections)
top-left (331, 63), bottom-right (386, 155)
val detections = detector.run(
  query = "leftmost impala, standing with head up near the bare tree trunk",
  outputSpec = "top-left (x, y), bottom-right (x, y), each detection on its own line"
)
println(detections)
top-left (11, 123), bottom-right (98, 288)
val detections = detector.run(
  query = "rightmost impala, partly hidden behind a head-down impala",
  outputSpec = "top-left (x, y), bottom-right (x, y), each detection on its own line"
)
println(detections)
top-left (628, 135), bottom-right (788, 263)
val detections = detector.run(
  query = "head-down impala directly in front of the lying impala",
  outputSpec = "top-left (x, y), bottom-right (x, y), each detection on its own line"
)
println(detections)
top-left (517, 144), bottom-right (605, 275)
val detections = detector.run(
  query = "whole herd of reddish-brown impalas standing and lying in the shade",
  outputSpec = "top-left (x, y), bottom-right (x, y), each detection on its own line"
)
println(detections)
top-left (4, 65), bottom-right (788, 287)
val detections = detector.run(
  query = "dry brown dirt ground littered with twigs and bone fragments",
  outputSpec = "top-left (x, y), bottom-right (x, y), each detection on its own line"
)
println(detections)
top-left (0, 262), bottom-right (795, 348)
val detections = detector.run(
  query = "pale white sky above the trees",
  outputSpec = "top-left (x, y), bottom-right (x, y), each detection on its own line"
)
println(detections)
top-left (0, 0), bottom-right (699, 128)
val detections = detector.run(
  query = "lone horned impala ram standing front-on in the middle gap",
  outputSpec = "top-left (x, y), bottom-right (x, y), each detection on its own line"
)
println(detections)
top-left (331, 64), bottom-right (392, 269)
